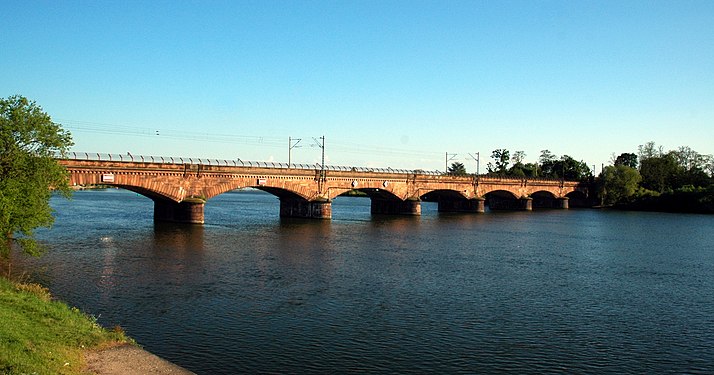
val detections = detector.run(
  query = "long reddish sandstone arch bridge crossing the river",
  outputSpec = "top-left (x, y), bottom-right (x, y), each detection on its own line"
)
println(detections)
top-left (58, 153), bottom-right (588, 223)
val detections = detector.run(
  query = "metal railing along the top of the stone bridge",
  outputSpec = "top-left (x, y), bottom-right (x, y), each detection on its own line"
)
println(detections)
top-left (56, 152), bottom-right (443, 176)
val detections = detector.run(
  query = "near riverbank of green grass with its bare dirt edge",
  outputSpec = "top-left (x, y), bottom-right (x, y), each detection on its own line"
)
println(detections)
top-left (0, 277), bottom-right (191, 375)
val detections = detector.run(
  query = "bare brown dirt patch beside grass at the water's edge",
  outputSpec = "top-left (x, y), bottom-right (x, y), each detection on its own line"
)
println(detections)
top-left (86, 345), bottom-right (195, 375)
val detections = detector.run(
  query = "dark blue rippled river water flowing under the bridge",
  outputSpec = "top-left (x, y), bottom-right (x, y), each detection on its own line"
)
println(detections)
top-left (13, 190), bottom-right (714, 374)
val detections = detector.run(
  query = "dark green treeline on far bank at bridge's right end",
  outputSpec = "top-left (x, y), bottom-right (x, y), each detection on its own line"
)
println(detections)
top-left (448, 142), bottom-right (714, 213)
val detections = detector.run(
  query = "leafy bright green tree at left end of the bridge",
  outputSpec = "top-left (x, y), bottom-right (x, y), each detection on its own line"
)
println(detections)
top-left (0, 95), bottom-right (73, 255)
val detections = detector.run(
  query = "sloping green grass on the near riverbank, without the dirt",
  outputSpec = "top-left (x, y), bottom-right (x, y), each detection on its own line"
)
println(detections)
top-left (0, 277), bottom-right (129, 374)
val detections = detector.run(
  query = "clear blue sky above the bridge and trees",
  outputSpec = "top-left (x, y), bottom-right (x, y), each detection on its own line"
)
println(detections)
top-left (0, 0), bottom-right (714, 172)
